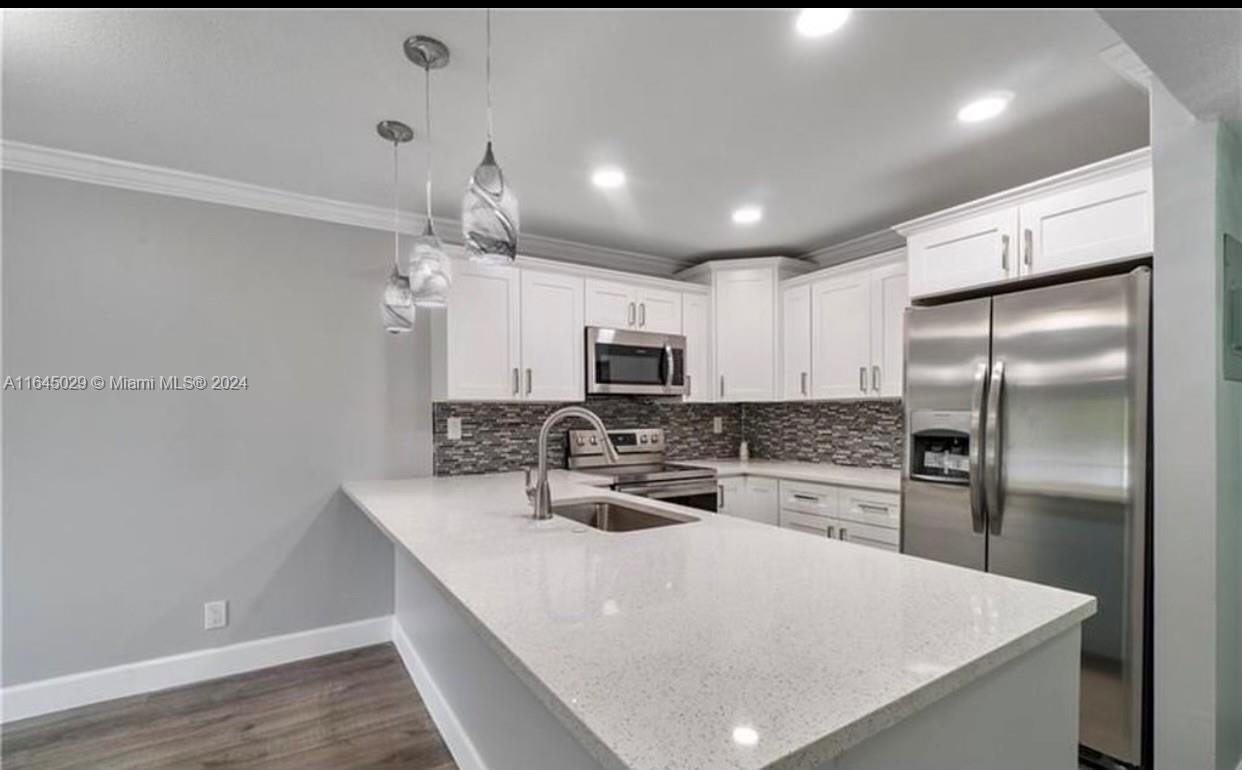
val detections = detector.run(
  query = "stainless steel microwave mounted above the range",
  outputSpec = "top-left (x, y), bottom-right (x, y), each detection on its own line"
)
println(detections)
top-left (586, 327), bottom-right (686, 396)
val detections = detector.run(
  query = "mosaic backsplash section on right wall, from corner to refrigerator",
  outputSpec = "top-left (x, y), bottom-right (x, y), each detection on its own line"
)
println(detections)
top-left (743, 401), bottom-right (905, 468)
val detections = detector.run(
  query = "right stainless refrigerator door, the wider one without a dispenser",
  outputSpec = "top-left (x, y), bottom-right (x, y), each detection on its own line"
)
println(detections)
top-left (984, 268), bottom-right (1150, 764)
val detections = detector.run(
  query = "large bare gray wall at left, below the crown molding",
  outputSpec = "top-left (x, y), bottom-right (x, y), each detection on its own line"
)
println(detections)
top-left (2, 173), bottom-right (431, 684)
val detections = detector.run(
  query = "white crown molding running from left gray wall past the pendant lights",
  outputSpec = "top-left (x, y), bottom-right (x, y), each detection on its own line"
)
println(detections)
top-left (0, 139), bottom-right (692, 276)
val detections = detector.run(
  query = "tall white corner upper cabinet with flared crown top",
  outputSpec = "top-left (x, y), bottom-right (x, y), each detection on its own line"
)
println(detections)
top-left (681, 257), bottom-right (814, 401)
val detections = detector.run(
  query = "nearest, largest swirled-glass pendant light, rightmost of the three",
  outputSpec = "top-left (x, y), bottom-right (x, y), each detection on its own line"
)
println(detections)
top-left (462, 9), bottom-right (518, 265)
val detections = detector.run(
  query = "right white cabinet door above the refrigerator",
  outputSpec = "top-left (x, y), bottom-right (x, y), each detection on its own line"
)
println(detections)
top-left (1020, 168), bottom-right (1153, 274)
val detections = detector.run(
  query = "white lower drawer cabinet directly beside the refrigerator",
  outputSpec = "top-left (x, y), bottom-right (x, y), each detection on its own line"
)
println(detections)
top-left (777, 481), bottom-right (902, 551)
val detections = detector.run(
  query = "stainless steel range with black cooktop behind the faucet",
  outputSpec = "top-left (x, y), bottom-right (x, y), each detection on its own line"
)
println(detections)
top-left (566, 427), bottom-right (719, 512)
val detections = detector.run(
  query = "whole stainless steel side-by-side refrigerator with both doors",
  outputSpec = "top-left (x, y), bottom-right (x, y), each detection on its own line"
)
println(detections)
top-left (902, 267), bottom-right (1151, 765)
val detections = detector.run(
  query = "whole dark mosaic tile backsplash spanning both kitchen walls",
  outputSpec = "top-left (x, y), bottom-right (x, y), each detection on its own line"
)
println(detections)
top-left (432, 396), bottom-right (903, 476)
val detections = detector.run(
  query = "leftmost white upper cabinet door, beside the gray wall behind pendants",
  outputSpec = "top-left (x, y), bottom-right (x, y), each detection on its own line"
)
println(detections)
top-left (445, 260), bottom-right (522, 401)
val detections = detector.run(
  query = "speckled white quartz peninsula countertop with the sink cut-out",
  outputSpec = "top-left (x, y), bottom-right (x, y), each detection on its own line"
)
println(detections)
top-left (344, 471), bottom-right (1095, 770)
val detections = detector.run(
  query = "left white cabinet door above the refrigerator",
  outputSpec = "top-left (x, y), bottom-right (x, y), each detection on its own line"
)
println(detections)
top-left (905, 207), bottom-right (1018, 297)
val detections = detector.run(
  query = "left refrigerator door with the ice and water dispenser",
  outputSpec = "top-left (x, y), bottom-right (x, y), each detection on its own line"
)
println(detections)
top-left (902, 298), bottom-right (991, 570)
